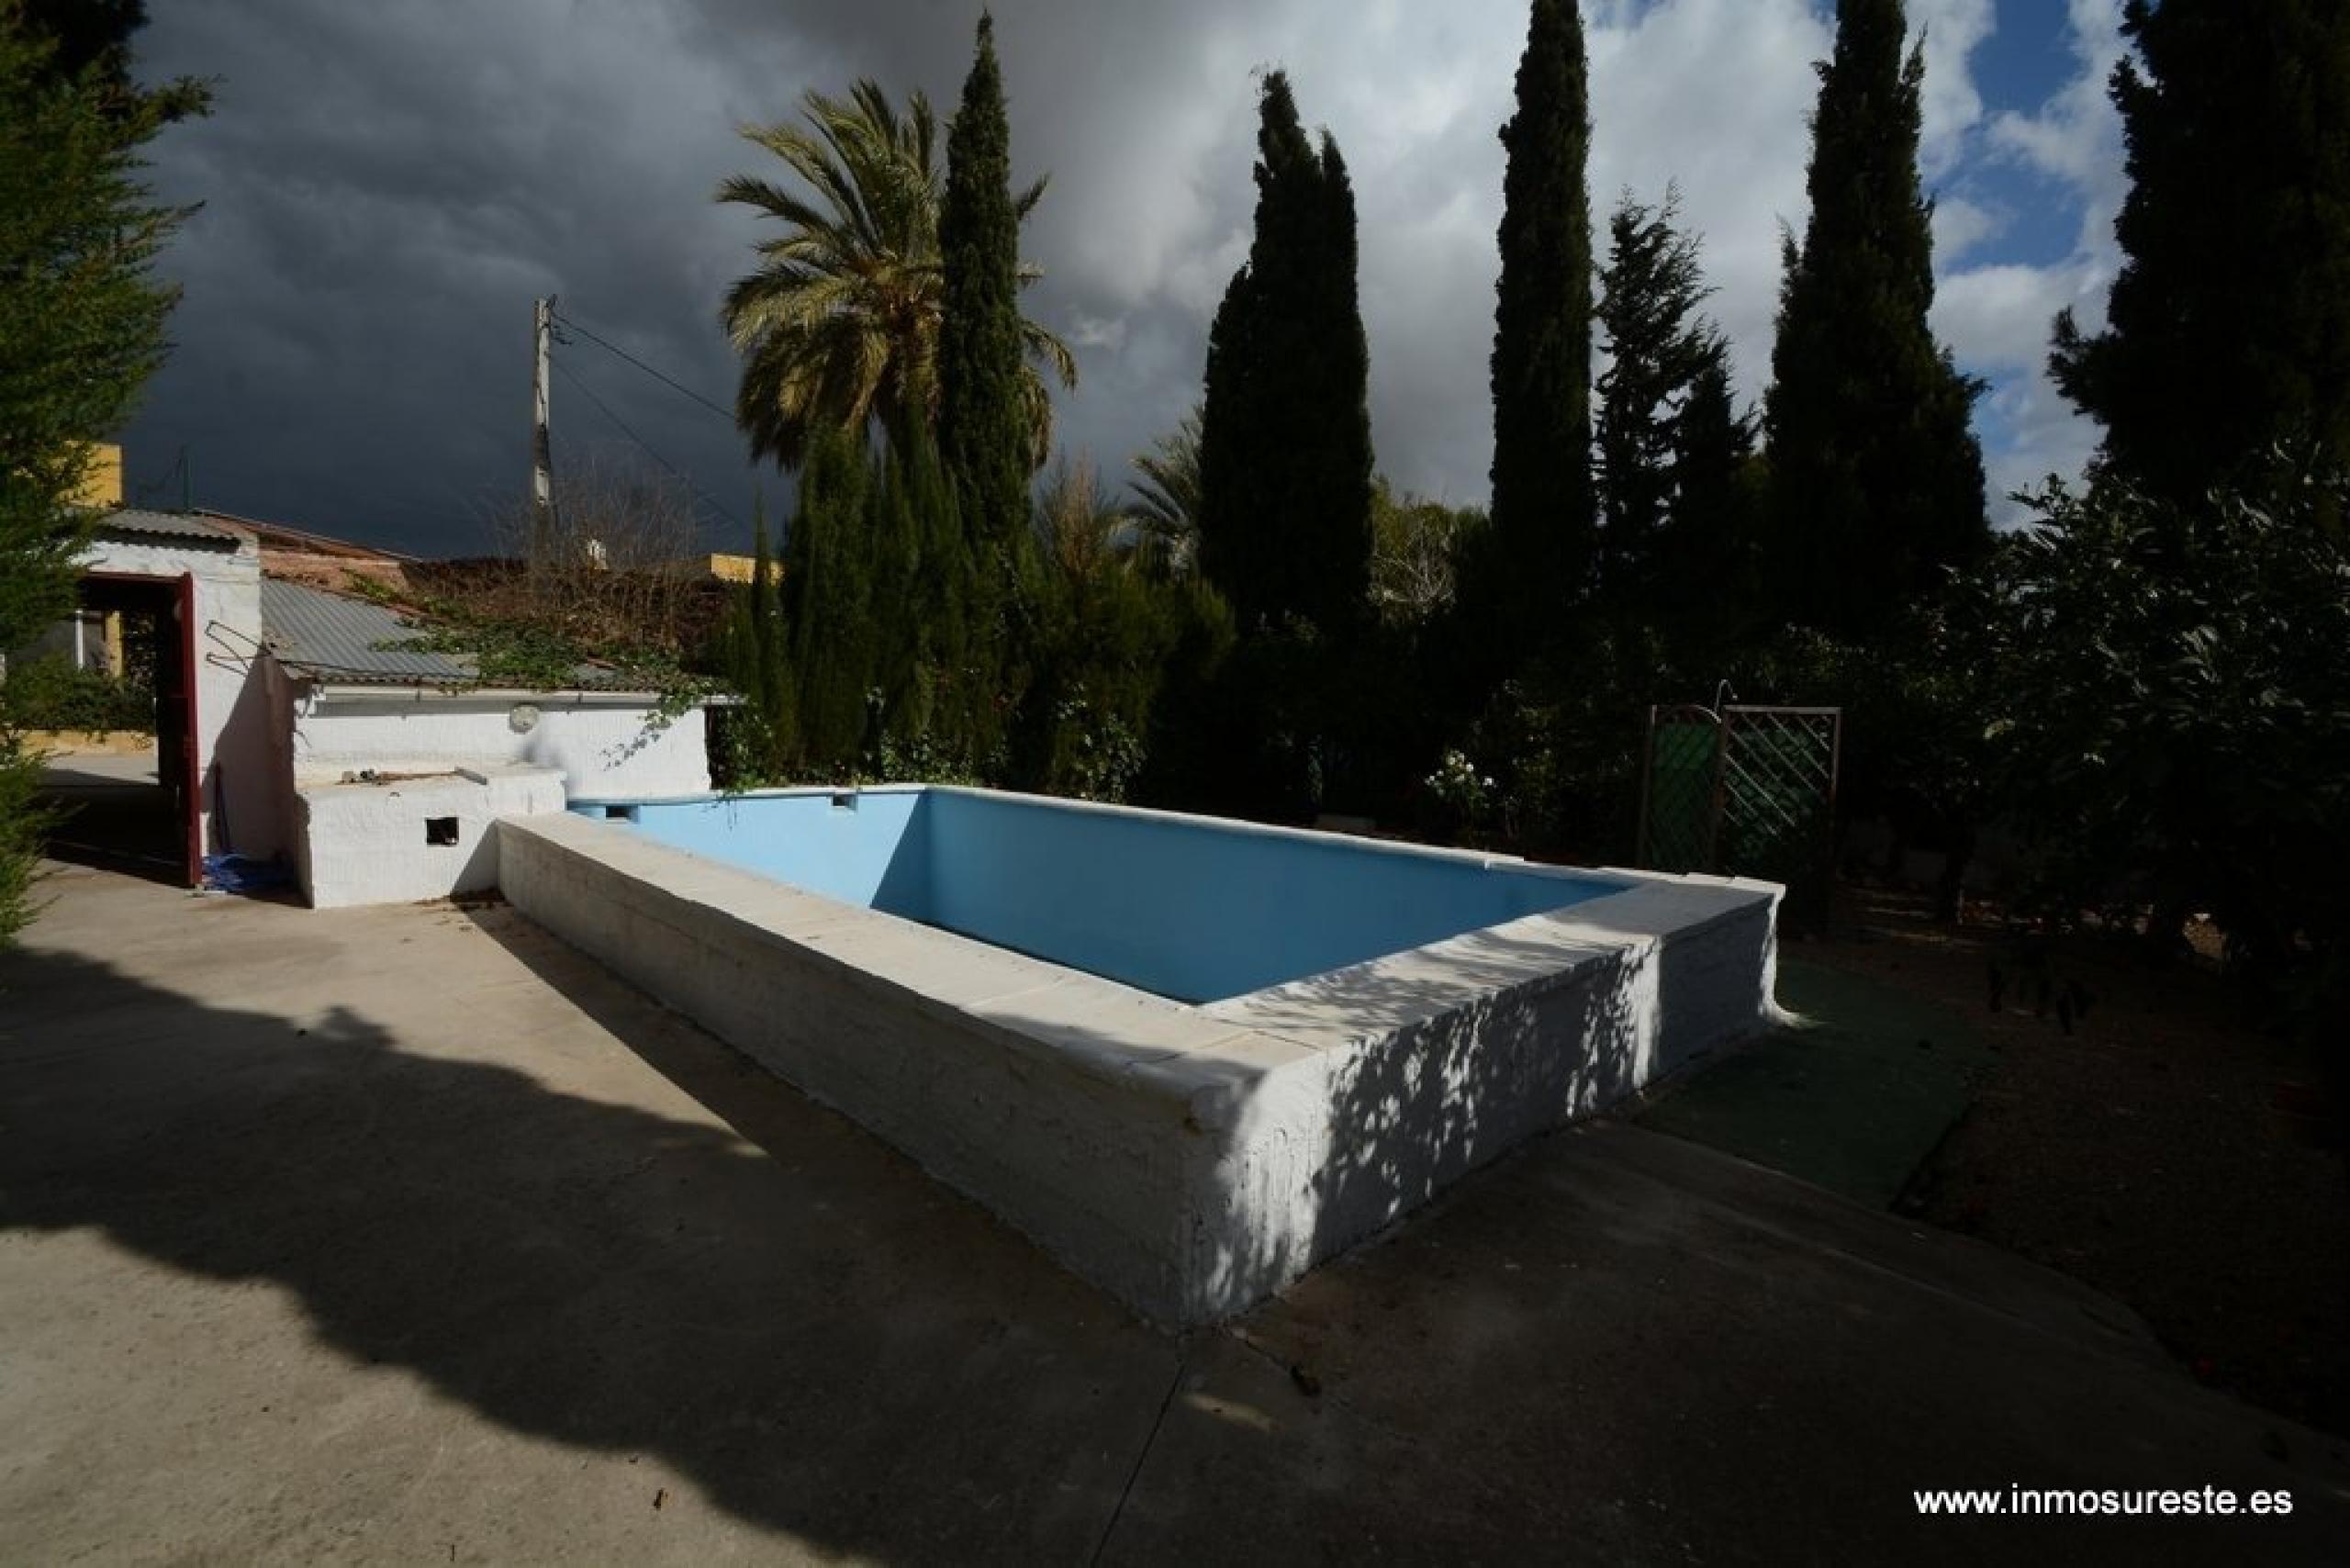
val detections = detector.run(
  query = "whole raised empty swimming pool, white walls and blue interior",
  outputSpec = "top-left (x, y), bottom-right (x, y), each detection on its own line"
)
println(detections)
top-left (496, 785), bottom-right (1779, 1324)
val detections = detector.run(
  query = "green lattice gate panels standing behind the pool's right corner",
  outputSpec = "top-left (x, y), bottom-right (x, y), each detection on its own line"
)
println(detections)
top-left (1640, 703), bottom-right (1845, 926)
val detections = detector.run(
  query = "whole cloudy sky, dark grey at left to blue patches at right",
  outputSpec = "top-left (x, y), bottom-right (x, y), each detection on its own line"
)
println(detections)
top-left (127, 0), bottom-right (2122, 553)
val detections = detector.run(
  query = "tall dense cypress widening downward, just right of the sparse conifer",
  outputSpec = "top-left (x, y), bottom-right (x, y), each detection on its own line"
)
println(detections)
top-left (1765, 0), bottom-right (1990, 637)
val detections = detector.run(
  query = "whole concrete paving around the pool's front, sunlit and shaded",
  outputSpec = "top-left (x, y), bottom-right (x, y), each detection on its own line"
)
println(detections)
top-left (0, 868), bottom-right (2350, 1563)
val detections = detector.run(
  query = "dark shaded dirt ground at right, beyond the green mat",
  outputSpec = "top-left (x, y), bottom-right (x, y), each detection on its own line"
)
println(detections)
top-left (1791, 891), bottom-right (2350, 1431)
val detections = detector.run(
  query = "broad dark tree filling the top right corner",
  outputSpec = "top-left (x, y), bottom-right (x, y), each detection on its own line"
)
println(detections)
top-left (2052, 0), bottom-right (2350, 503)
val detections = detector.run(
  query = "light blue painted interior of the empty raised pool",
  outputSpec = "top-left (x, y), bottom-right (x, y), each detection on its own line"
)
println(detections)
top-left (574, 788), bottom-right (1621, 1002)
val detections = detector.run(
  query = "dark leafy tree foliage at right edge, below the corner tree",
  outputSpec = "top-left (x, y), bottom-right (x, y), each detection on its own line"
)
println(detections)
top-left (1986, 456), bottom-right (2350, 973)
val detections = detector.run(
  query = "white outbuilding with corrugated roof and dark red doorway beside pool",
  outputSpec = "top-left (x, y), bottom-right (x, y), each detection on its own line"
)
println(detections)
top-left (59, 508), bottom-right (710, 907)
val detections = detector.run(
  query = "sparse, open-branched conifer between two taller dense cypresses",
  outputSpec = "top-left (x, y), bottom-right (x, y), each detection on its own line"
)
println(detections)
top-left (1598, 190), bottom-right (1728, 607)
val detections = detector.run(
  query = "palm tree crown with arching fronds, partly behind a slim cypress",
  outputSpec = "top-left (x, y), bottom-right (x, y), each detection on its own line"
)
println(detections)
top-left (717, 80), bottom-right (1076, 468)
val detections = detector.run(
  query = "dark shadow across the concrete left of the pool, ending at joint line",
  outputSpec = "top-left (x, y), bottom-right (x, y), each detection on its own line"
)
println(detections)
top-left (0, 931), bottom-right (1175, 1561)
